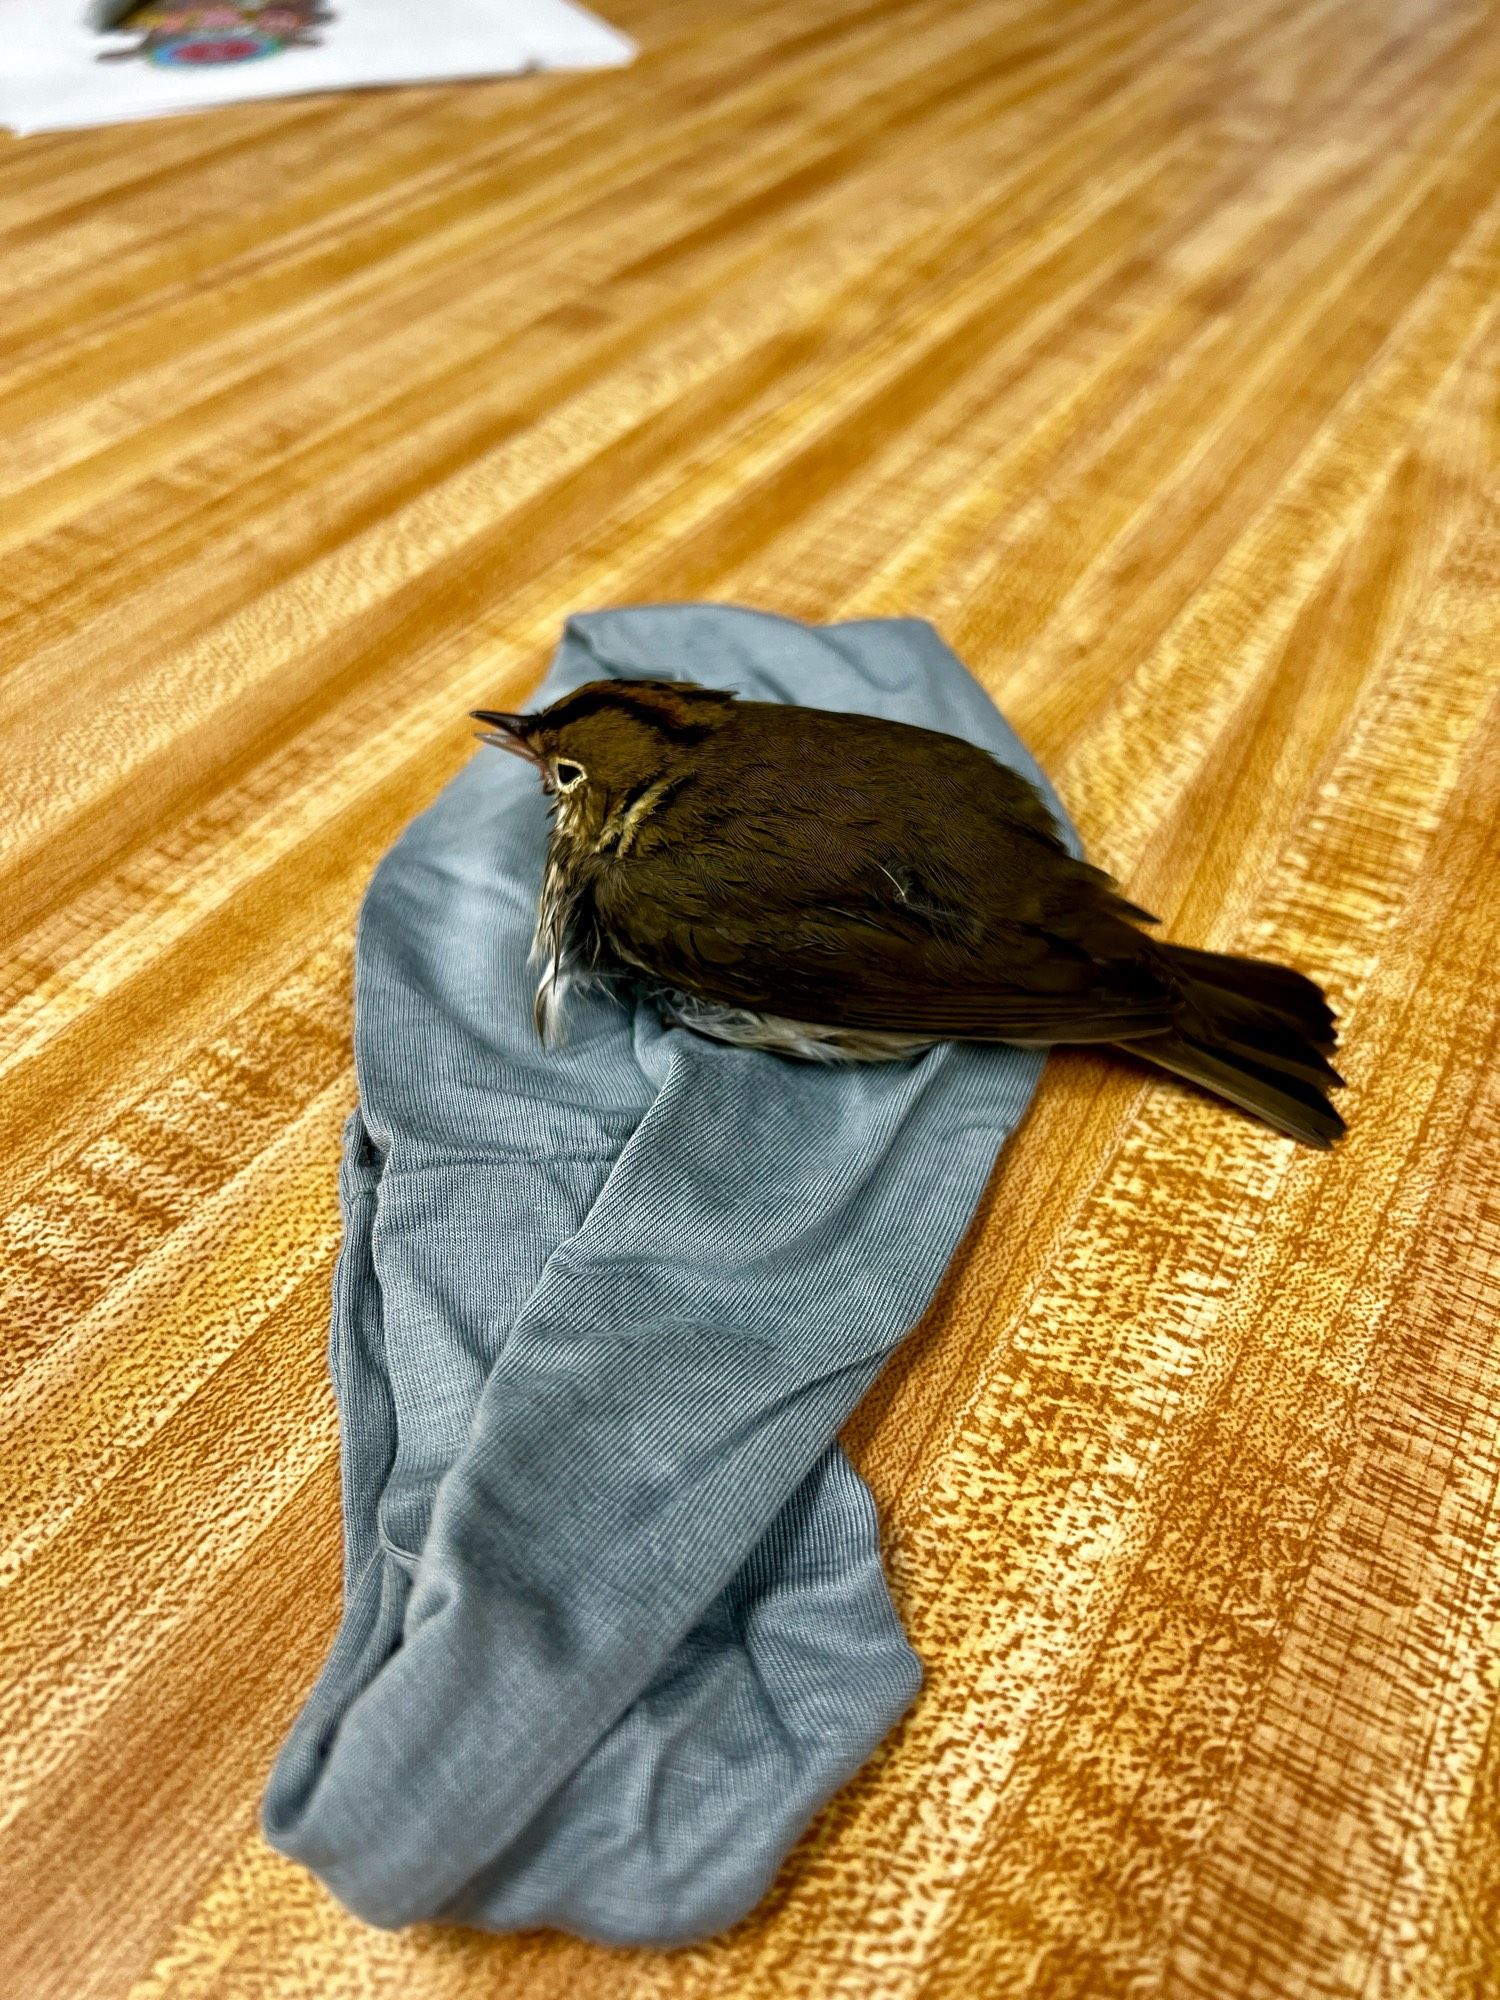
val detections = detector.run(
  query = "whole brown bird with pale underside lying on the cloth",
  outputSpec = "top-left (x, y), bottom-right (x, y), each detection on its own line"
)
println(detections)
top-left (474, 680), bottom-right (1344, 1146)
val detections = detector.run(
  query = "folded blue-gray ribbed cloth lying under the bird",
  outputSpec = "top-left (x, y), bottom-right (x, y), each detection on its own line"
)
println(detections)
top-left (264, 606), bottom-right (1080, 1946)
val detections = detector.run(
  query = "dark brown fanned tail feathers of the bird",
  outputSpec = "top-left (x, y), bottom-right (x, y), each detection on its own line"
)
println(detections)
top-left (1126, 944), bottom-right (1344, 1146)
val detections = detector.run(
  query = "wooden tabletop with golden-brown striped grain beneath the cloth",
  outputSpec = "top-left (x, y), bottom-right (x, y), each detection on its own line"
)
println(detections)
top-left (0, 0), bottom-right (1500, 2000)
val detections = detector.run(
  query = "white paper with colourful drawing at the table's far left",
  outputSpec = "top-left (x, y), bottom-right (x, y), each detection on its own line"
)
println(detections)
top-left (0, 0), bottom-right (636, 132)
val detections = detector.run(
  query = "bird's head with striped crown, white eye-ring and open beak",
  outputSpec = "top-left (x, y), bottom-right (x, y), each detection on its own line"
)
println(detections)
top-left (470, 680), bottom-right (734, 854)
